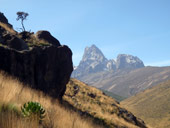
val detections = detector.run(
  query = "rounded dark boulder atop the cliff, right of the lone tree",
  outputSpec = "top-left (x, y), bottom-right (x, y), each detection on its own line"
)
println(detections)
top-left (35, 31), bottom-right (60, 46)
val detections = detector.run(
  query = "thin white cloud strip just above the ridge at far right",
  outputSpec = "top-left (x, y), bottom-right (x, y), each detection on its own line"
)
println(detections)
top-left (145, 60), bottom-right (170, 66)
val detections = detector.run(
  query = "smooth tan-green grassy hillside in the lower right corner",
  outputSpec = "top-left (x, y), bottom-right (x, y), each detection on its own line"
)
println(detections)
top-left (121, 80), bottom-right (170, 128)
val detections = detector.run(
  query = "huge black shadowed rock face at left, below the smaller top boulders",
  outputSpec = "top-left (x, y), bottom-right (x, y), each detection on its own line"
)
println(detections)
top-left (0, 46), bottom-right (73, 99)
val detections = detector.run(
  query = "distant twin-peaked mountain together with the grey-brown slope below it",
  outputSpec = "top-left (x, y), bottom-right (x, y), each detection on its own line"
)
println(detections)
top-left (72, 45), bottom-right (170, 97)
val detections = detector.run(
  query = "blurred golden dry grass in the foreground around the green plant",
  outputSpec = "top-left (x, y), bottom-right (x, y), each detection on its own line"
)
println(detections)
top-left (0, 73), bottom-right (102, 128)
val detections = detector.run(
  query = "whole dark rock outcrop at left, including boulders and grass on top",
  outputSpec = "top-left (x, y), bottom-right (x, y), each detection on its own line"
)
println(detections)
top-left (0, 12), bottom-right (73, 99)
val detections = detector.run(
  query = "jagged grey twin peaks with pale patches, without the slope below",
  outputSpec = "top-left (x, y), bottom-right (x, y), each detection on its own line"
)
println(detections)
top-left (72, 45), bottom-right (144, 79)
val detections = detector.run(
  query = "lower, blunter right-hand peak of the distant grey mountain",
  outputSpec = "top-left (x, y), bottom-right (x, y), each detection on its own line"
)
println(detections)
top-left (117, 54), bottom-right (144, 69)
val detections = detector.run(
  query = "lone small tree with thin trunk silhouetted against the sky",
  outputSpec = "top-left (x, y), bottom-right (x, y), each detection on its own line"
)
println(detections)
top-left (16, 12), bottom-right (29, 31)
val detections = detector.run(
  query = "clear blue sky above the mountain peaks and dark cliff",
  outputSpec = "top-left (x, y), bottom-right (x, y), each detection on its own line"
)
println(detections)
top-left (0, 0), bottom-right (170, 66)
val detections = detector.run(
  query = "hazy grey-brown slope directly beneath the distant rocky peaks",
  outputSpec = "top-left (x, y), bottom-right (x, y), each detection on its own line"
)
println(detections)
top-left (80, 67), bottom-right (170, 97)
